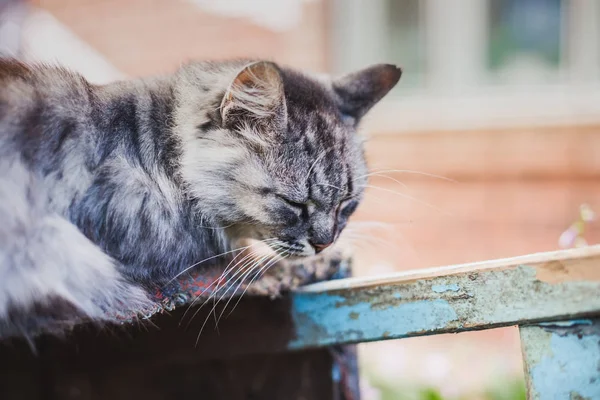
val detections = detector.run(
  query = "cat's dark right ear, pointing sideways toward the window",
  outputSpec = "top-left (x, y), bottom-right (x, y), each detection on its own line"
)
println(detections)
top-left (333, 64), bottom-right (402, 121)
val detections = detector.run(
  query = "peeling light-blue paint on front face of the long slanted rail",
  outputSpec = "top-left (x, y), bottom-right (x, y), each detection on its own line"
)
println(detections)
top-left (290, 265), bottom-right (600, 348)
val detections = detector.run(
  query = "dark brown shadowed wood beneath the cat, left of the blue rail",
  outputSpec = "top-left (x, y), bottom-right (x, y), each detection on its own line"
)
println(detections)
top-left (0, 297), bottom-right (360, 400)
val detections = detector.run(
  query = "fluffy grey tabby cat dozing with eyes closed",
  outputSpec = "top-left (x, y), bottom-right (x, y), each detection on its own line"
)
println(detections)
top-left (0, 59), bottom-right (401, 333)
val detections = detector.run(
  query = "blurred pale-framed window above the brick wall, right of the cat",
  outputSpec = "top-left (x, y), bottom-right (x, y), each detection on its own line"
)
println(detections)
top-left (331, 0), bottom-right (600, 131)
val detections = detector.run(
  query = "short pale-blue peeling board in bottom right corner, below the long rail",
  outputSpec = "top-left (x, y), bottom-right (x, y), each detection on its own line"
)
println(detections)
top-left (520, 319), bottom-right (600, 400)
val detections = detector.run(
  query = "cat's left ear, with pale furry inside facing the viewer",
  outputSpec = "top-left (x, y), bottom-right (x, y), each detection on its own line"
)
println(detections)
top-left (220, 61), bottom-right (287, 128)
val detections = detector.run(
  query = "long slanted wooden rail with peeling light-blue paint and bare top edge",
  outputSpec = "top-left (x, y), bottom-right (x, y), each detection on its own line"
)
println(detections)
top-left (288, 246), bottom-right (600, 349)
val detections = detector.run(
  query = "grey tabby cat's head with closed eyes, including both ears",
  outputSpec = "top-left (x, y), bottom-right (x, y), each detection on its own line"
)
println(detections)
top-left (176, 61), bottom-right (401, 256)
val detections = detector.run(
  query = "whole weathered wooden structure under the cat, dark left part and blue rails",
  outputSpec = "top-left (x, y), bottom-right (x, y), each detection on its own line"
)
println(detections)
top-left (0, 246), bottom-right (600, 400)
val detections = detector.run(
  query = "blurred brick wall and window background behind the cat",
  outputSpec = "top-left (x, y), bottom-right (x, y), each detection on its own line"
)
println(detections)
top-left (0, 0), bottom-right (600, 400)
